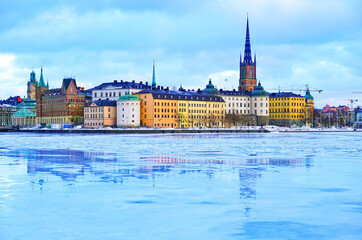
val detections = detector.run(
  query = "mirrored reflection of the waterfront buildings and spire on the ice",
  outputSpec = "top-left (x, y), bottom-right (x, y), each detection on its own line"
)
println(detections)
top-left (0, 148), bottom-right (313, 217)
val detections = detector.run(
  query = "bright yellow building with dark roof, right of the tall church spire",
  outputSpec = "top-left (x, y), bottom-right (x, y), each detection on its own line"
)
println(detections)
top-left (269, 92), bottom-right (306, 126)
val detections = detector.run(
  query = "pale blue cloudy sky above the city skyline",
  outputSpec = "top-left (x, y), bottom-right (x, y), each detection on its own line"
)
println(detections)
top-left (0, 0), bottom-right (362, 107)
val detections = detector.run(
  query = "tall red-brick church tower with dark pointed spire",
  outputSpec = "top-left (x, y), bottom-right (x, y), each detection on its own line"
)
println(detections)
top-left (238, 17), bottom-right (257, 92)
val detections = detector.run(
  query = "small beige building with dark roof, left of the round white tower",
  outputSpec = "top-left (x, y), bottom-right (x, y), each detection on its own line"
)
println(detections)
top-left (84, 100), bottom-right (117, 128)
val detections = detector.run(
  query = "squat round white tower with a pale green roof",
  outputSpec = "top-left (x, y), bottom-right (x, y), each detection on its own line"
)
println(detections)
top-left (117, 95), bottom-right (141, 127)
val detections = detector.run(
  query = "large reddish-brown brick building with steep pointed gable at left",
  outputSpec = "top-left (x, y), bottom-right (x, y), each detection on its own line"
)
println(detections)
top-left (36, 78), bottom-right (86, 124)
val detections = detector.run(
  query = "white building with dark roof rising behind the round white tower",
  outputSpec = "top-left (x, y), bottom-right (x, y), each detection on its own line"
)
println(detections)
top-left (90, 80), bottom-right (151, 101)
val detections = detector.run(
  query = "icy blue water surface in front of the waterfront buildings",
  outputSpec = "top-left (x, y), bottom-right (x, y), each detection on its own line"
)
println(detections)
top-left (0, 132), bottom-right (362, 240)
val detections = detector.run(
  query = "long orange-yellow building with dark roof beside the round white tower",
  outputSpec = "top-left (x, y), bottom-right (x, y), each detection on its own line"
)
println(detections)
top-left (134, 89), bottom-right (225, 128)
